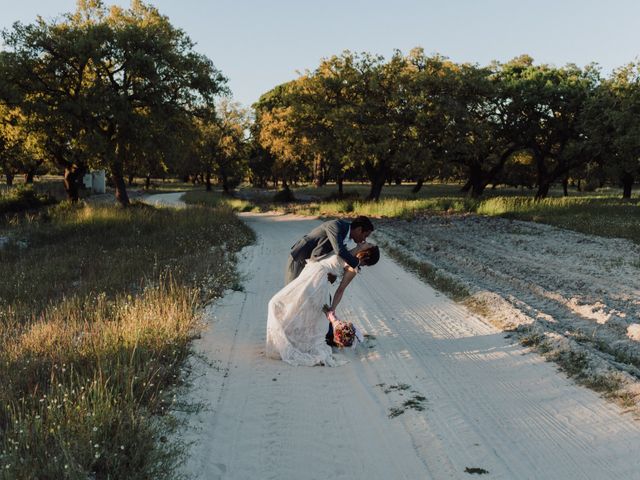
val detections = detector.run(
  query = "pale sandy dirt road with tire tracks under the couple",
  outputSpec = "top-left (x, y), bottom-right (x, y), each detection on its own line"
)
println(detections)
top-left (151, 199), bottom-right (640, 480)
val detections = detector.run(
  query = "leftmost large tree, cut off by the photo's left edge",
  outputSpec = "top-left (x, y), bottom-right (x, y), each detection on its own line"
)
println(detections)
top-left (0, 11), bottom-right (97, 201)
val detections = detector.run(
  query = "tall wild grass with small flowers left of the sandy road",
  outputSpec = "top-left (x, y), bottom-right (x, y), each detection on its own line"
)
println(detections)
top-left (0, 204), bottom-right (253, 480)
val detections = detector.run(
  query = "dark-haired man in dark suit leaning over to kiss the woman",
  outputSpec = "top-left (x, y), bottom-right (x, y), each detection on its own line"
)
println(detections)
top-left (285, 216), bottom-right (373, 285)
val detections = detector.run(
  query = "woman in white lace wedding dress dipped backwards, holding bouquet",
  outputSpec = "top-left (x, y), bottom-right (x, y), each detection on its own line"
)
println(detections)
top-left (266, 243), bottom-right (380, 366)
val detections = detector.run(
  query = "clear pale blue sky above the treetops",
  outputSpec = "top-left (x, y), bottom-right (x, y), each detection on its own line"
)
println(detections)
top-left (0, 0), bottom-right (640, 107)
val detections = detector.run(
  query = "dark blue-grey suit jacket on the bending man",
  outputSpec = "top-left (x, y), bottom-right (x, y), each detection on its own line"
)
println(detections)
top-left (291, 220), bottom-right (359, 268)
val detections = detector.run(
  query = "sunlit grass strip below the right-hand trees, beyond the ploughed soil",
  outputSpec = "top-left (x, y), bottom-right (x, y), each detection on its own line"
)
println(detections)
top-left (222, 184), bottom-right (640, 244)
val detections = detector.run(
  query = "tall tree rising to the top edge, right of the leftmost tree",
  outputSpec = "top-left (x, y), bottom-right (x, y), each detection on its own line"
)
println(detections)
top-left (89, 0), bottom-right (226, 205)
